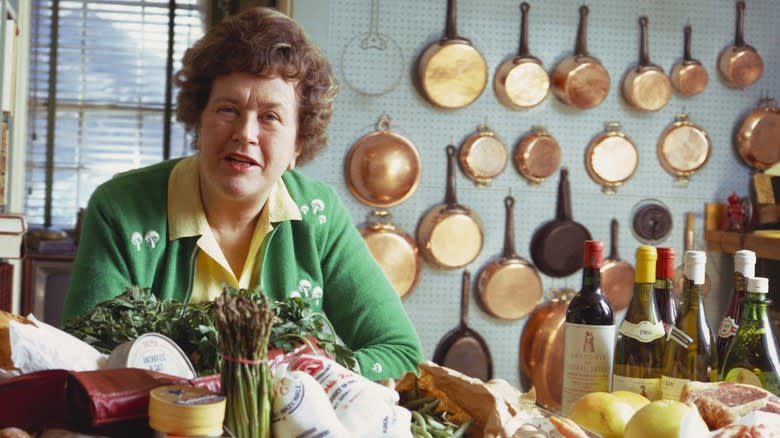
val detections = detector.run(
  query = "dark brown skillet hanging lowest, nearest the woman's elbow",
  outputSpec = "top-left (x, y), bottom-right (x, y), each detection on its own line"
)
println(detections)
top-left (433, 270), bottom-right (493, 382)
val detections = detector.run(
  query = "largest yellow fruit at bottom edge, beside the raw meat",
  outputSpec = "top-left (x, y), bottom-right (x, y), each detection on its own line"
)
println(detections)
top-left (623, 400), bottom-right (710, 438)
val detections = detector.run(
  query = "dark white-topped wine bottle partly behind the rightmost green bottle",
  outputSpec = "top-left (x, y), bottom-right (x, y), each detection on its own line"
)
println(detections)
top-left (716, 249), bottom-right (756, 359)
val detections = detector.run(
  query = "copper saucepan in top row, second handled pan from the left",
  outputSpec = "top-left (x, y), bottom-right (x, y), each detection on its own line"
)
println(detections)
top-left (493, 2), bottom-right (550, 110)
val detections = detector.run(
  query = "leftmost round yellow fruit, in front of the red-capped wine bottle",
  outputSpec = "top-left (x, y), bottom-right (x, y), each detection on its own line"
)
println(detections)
top-left (568, 391), bottom-right (635, 438)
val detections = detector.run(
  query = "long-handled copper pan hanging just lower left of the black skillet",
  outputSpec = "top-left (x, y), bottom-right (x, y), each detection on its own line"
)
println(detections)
top-left (477, 195), bottom-right (542, 320)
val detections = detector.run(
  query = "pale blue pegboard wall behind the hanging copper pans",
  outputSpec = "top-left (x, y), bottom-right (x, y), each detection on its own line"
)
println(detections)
top-left (294, 0), bottom-right (780, 387)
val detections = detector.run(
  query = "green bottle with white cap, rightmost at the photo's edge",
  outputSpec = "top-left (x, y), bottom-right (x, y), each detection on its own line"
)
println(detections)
top-left (721, 277), bottom-right (780, 396)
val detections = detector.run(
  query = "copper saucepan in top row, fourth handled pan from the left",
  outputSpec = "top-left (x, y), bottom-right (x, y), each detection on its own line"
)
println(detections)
top-left (622, 15), bottom-right (672, 111)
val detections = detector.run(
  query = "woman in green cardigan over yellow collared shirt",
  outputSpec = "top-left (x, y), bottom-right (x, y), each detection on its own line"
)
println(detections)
top-left (64, 8), bottom-right (422, 380)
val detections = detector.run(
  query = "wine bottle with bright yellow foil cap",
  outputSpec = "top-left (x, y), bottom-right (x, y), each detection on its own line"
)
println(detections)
top-left (612, 245), bottom-right (665, 401)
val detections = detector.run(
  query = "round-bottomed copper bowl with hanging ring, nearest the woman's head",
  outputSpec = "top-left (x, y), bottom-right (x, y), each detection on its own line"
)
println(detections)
top-left (344, 115), bottom-right (422, 208)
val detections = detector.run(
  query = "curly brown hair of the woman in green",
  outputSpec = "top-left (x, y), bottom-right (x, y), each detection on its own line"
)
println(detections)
top-left (174, 7), bottom-right (337, 164)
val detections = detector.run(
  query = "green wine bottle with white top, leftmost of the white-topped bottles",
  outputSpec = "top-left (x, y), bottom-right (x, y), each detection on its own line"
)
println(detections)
top-left (661, 251), bottom-right (719, 400)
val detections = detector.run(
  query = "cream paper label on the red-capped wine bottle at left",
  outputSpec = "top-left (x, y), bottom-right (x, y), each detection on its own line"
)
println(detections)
top-left (561, 322), bottom-right (615, 415)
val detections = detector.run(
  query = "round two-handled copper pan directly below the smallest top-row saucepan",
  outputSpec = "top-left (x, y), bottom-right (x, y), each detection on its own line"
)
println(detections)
top-left (656, 114), bottom-right (712, 185)
